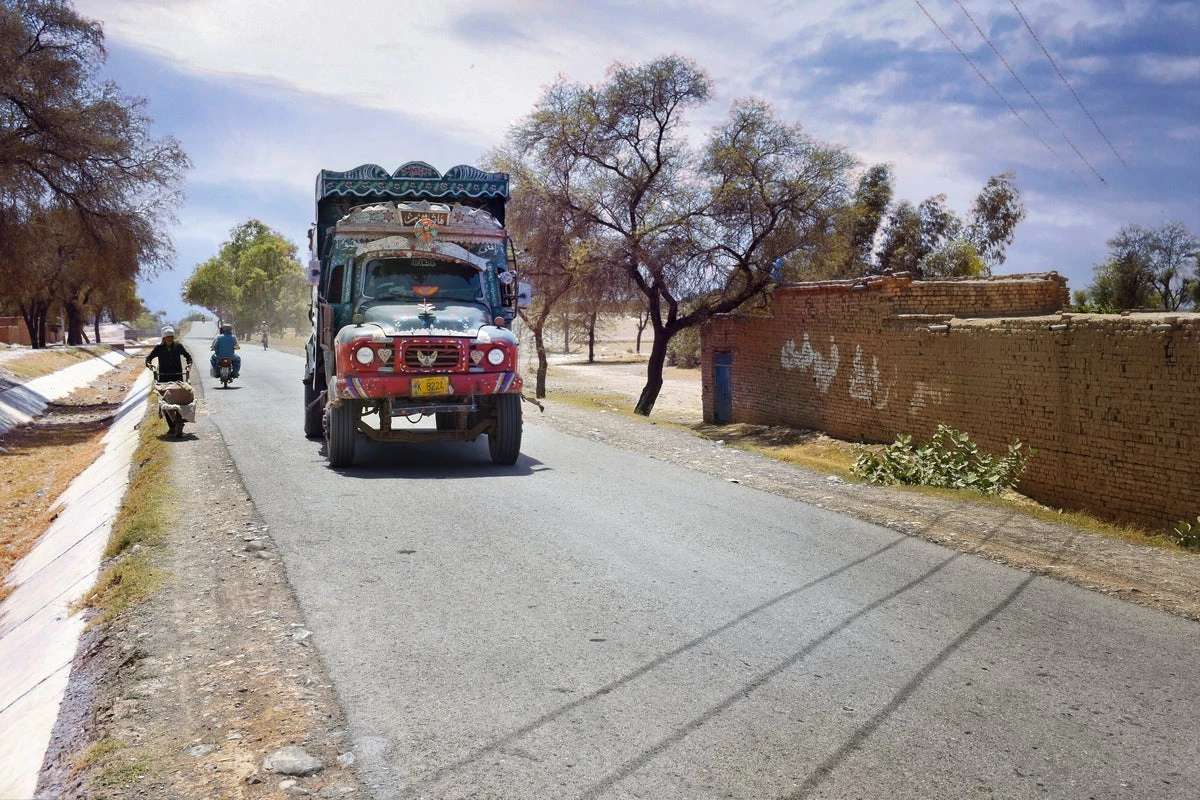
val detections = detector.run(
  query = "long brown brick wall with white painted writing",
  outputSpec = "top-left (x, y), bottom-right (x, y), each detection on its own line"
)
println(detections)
top-left (702, 273), bottom-right (1200, 530)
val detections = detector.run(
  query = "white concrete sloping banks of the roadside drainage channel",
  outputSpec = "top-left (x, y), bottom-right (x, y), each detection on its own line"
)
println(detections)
top-left (0, 353), bottom-right (151, 798)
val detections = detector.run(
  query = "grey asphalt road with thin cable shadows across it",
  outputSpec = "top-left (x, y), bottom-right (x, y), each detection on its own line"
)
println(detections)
top-left (188, 327), bottom-right (1200, 800)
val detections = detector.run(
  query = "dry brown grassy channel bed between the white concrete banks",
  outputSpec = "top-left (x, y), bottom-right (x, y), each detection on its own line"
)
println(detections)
top-left (0, 360), bottom-right (139, 600)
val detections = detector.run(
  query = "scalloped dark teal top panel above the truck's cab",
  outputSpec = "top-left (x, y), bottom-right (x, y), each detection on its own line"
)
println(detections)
top-left (316, 161), bottom-right (509, 260)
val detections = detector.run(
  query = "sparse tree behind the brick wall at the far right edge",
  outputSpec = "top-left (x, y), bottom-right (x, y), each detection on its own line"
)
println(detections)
top-left (1087, 222), bottom-right (1200, 311)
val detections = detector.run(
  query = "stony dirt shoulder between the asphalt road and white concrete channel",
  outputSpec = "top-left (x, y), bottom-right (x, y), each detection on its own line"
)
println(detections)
top-left (38, 379), bottom-right (366, 800)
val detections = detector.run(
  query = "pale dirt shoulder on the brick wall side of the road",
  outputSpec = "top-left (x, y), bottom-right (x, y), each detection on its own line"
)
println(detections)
top-left (537, 359), bottom-right (1200, 620)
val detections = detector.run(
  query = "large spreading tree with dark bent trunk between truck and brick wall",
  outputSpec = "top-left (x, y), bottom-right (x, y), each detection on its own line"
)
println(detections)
top-left (515, 56), bottom-right (852, 415)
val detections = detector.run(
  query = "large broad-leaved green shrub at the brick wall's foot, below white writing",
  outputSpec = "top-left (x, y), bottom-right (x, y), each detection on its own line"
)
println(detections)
top-left (853, 425), bottom-right (1033, 494)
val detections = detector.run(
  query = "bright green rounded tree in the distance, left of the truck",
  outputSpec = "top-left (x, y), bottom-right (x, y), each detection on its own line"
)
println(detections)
top-left (182, 219), bottom-right (310, 338)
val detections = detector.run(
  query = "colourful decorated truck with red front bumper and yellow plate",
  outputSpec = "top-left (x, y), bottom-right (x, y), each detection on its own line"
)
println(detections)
top-left (304, 162), bottom-right (528, 467)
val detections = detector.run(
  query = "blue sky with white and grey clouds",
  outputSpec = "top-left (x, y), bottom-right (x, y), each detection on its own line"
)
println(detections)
top-left (74, 0), bottom-right (1200, 320)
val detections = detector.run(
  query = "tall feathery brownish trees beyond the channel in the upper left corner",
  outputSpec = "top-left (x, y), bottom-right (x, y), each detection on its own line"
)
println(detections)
top-left (0, 0), bottom-right (190, 347)
